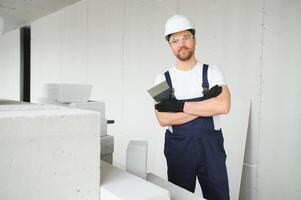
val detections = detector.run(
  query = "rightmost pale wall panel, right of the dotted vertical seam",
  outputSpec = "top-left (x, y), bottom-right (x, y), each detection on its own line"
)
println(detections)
top-left (257, 0), bottom-right (301, 200)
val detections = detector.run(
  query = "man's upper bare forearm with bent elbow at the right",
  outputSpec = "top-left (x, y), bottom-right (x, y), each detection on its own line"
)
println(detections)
top-left (183, 86), bottom-right (231, 117)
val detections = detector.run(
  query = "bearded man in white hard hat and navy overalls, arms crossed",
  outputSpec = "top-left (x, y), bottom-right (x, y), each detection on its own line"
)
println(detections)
top-left (155, 15), bottom-right (230, 200)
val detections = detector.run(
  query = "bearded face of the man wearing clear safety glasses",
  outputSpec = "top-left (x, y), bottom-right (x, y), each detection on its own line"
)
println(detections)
top-left (169, 31), bottom-right (195, 61)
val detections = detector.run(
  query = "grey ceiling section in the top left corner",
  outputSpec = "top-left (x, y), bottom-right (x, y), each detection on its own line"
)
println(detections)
top-left (0, 0), bottom-right (80, 33)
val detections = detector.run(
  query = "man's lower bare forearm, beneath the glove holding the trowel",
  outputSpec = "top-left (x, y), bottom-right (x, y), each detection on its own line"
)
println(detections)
top-left (155, 110), bottom-right (198, 127)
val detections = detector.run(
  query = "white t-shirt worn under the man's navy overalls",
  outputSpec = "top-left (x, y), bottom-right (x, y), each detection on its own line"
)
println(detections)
top-left (155, 62), bottom-right (226, 131)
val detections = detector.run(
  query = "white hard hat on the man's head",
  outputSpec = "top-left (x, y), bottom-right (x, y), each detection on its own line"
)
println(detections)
top-left (164, 15), bottom-right (194, 37)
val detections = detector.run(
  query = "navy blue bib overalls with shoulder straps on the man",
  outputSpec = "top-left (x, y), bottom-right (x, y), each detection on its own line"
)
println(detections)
top-left (164, 65), bottom-right (230, 200)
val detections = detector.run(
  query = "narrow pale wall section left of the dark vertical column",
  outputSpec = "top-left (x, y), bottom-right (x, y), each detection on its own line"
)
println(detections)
top-left (0, 30), bottom-right (20, 100)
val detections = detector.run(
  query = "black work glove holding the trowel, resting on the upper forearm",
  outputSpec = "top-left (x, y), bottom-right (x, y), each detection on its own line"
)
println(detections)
top-left (155, 98), bottom-right (185, 112)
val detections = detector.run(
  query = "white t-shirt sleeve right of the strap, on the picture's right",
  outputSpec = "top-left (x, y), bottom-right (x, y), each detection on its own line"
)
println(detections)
top-left (208, 65), bottom-right (226, 88)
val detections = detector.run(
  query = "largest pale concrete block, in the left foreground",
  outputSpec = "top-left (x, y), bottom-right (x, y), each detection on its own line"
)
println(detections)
top-left (0, 105), bottom-right (100, 200)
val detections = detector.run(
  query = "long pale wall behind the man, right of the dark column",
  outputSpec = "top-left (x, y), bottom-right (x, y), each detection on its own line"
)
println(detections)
top-left (28, 0), bottom-right (301, 200)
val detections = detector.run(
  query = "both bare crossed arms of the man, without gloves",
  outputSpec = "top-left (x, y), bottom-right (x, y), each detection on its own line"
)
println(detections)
top-left (155, 85), bottom-right (231, 126)
